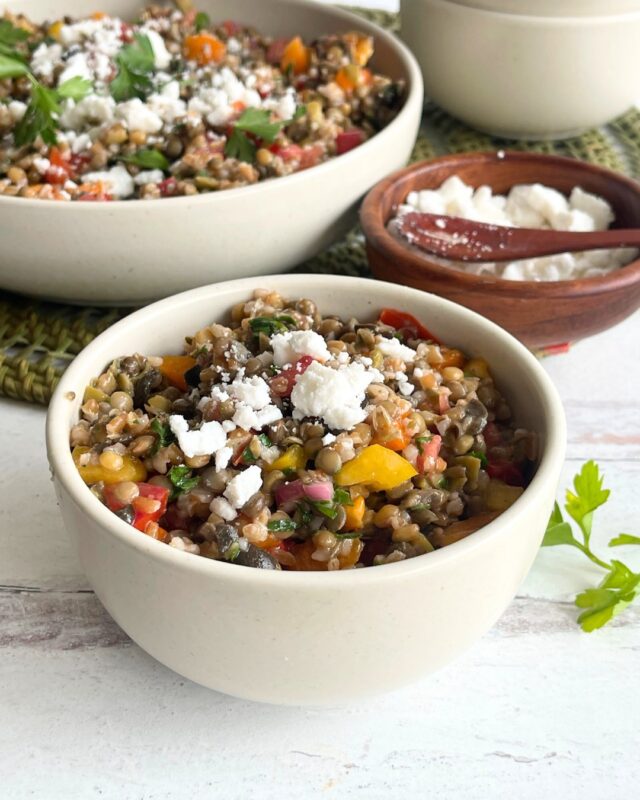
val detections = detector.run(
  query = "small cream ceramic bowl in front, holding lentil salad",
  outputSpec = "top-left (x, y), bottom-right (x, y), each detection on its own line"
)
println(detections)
top-left (47, 275), bottom-right (565, 704)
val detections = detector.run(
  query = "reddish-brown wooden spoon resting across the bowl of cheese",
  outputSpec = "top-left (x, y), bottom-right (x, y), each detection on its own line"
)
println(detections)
top-left (394, 211), bottom-right (640, 261)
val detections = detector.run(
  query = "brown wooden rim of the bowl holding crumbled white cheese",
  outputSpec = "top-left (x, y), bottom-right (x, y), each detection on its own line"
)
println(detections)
top-left (360, 149), bottom-right (640, 298)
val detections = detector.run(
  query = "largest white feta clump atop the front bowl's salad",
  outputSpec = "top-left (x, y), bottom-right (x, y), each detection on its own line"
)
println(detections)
top-left (291, 361), bottom-right (383, 430)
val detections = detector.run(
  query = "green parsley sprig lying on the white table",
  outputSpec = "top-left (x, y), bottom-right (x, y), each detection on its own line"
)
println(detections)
top-left (542, 461), bottom-right (640, 633)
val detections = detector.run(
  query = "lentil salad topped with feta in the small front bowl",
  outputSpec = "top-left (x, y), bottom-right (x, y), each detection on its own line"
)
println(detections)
top-left (70, 290), bottom-right (536, 570)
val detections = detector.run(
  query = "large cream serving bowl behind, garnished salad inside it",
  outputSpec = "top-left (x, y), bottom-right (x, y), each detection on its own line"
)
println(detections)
top-left (0, 0), bottom-right (423, 305)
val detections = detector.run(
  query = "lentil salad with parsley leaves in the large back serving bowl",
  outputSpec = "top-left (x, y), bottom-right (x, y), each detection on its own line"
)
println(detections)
top-left (0, 5), bottom-right (405, 201)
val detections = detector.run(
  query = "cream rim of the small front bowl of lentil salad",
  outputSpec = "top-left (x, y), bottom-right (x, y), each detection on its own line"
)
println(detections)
top-left (46, 274), bottom-right (566, 590)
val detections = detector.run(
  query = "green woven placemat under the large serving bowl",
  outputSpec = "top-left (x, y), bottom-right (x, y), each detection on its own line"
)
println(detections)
top-left (0, 9), bottom-right (640, 405)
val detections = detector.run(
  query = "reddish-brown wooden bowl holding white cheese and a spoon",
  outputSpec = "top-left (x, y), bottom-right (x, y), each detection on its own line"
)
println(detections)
top-left (360, 152), bottom-right (640, 347)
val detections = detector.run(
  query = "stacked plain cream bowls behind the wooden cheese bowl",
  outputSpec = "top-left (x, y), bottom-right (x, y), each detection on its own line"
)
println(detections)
top-left (401, 0), bottom-right (640, 139)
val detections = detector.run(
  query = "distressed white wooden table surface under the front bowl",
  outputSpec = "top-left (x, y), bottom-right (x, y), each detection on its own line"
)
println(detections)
top-left (0, 0), bottom-right (640, 800)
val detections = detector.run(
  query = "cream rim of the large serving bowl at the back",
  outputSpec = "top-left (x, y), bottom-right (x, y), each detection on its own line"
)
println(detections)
top-left (0, 0), bottom-right (424, 214)
